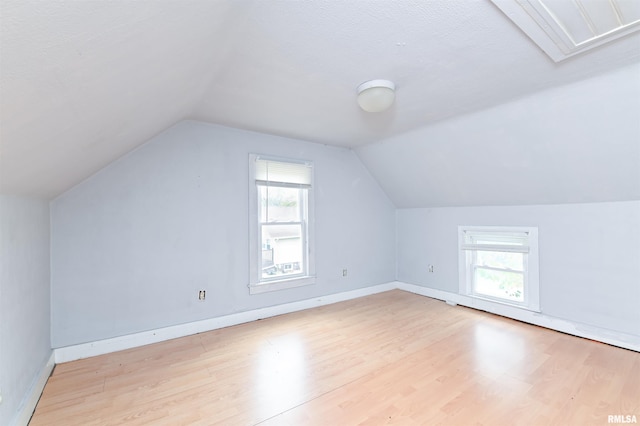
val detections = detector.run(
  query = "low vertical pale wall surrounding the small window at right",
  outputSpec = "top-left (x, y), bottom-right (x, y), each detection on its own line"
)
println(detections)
top-left (397, 201), bottom-right (640, 336)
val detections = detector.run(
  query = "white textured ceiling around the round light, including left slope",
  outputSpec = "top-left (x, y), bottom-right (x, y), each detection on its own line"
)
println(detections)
top-left (0, 0), bottom-right (640, 197)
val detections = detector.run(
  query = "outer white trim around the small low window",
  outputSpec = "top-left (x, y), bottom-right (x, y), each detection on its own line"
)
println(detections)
top-left (458, 226), bottom-right (540, 312)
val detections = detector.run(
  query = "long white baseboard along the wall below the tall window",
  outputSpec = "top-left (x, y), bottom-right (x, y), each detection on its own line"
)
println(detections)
top-left (54, 282), bottom-right (398, 364)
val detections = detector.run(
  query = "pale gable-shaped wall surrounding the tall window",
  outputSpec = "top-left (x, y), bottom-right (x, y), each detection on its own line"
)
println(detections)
top-left (51, 121), bottom-right (395, 347)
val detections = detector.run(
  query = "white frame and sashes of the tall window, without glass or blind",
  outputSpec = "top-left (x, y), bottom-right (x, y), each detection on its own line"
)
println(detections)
top-left (249, 153), bottom-right (315, 294)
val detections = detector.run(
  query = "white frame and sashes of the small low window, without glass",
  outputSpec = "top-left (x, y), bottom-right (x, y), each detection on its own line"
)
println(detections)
top-left (458, 226), bottom-right (540, 312)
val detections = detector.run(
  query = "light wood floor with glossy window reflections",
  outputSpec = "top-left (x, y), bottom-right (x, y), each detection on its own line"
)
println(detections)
top-left (30, 290), bottom-right (640, 426)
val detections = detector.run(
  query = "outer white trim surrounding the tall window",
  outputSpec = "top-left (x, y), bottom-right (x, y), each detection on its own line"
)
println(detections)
top-left (249, 154), bottom-right (316, 294)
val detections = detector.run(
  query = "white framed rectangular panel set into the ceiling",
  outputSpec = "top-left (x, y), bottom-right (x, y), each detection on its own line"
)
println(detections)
top-left (491, 0), bottom-right (640, 62)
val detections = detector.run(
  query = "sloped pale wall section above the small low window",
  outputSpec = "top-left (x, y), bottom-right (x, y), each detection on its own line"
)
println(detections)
top-left (356, 64), bottom-right (640, 208)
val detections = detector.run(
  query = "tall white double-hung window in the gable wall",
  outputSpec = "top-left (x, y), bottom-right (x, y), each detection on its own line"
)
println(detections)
top-left (249, 154), bottom-right (314, 294)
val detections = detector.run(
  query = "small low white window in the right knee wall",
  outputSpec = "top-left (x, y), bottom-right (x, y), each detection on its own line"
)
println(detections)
top-left (458, 226), bottom-right (540, 311)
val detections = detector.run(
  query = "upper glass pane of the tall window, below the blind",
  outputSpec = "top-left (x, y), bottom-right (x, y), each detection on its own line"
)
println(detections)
top-left (258, 185), bottom-right (303, 223)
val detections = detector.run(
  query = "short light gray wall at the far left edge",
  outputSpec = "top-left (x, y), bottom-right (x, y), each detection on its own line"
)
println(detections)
top-left (0, 195), bottom-right (51, 425)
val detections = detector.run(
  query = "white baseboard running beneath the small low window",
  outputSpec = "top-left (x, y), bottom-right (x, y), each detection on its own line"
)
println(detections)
top-left (396, 281), bottom-right (640, 352)
